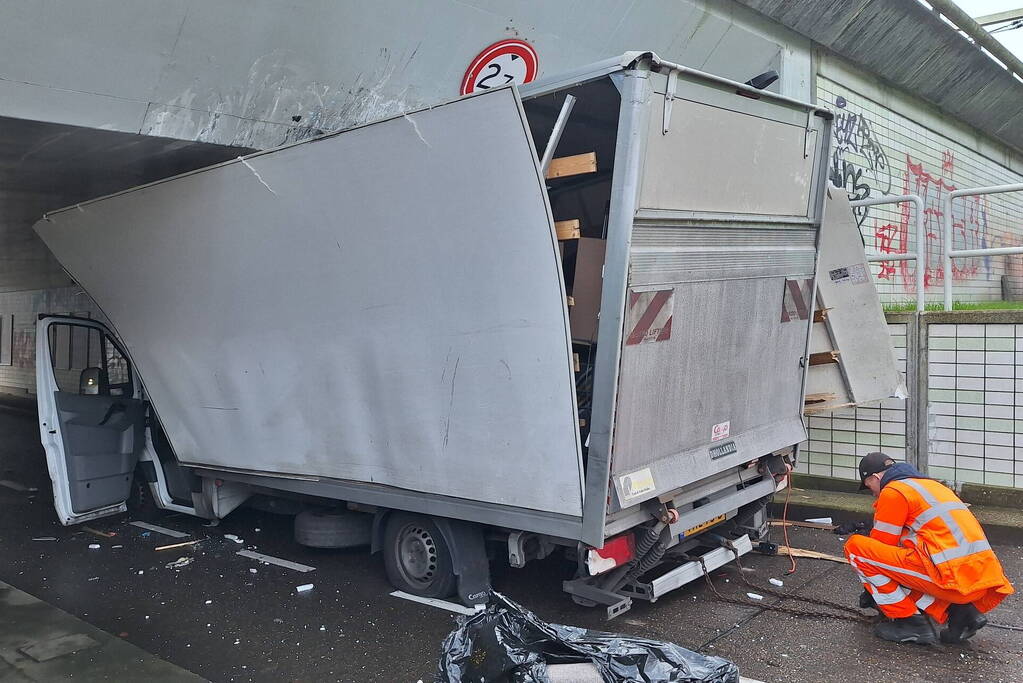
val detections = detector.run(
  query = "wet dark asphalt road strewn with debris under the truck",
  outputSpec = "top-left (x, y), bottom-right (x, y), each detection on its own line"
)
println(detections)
top-left (0, 400), bottom-right (1023, 683)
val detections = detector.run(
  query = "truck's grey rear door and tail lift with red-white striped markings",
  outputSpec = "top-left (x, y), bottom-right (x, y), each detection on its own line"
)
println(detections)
top-left (611, 74), bottom-right (829, 511)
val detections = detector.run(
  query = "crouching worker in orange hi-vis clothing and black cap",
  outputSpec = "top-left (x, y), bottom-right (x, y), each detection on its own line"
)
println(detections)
top-left (845, 453), bottom-right (1014, 644)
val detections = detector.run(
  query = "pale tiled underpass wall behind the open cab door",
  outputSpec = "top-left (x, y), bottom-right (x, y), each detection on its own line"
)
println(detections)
top-left (0, 287), bottom-right (104, 394)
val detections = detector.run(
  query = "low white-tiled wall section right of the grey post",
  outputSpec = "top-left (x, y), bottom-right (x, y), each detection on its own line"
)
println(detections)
top-left (927, 323), bottom-right (1023, 488)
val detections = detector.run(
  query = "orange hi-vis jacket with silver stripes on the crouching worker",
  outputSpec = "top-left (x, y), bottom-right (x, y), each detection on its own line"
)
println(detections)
top-left (871, 479), bottom-right (1012, 593)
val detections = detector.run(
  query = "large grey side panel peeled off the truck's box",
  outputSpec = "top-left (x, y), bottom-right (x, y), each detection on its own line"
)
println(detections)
top-left (36, 89), bottom-right (582, 518)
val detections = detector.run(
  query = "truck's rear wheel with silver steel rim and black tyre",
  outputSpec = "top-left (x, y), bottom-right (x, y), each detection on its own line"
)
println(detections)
top-left (384, 512), bottom-right (458, 598)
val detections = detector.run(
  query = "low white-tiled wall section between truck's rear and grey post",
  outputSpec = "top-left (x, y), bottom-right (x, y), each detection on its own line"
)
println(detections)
top-left (797, 323), bottom-right (906, 479)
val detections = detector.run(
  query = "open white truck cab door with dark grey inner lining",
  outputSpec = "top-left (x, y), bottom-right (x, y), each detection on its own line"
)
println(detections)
top-left (36, 316), bottom-right (145, 526)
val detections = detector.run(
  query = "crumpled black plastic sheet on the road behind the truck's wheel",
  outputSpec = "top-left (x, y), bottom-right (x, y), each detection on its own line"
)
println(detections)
top-left (437, 593), bottom-right (739, 683)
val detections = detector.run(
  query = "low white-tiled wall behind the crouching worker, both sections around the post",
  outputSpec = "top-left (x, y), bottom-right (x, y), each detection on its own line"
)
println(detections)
top-left (797, 312), bottom-right (1023, 489)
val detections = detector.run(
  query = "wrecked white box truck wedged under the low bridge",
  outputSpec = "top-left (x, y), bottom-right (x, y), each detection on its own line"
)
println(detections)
top-left (29, 52), bottom-right (891, 616)
